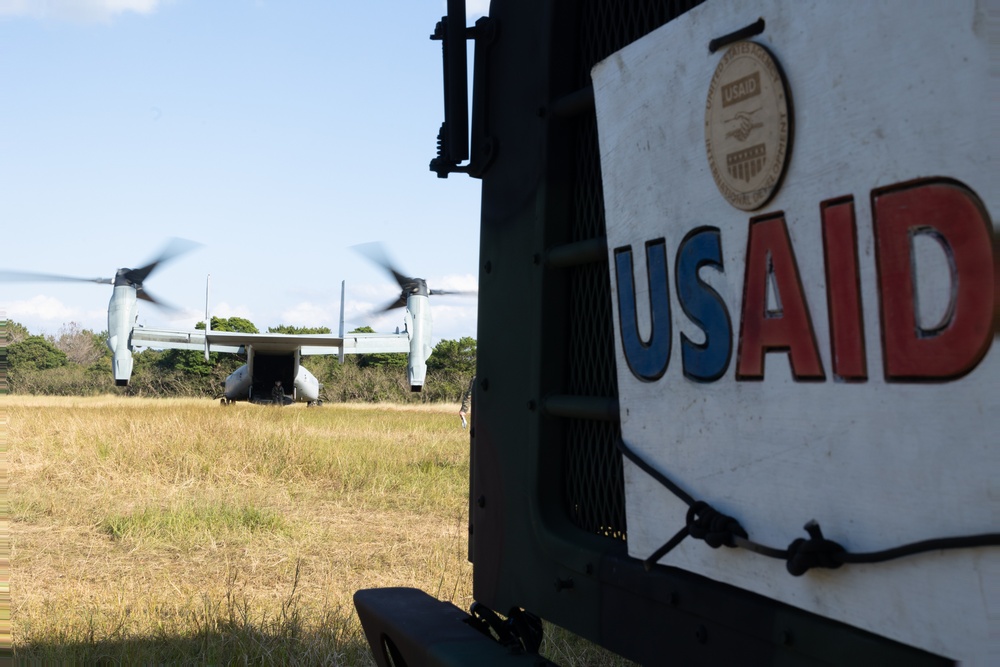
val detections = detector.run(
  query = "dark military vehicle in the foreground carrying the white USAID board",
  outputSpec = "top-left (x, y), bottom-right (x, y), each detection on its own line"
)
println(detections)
top-left (355, 0), bottom-right (1000, 666)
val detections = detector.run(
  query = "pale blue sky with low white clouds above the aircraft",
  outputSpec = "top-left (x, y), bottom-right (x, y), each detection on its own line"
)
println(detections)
top-left (0, 0), bottom-right (488, 340)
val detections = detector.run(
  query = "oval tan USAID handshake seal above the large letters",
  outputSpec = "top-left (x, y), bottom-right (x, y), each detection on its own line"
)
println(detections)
top-left (705, 42), bottom-right (791, 211)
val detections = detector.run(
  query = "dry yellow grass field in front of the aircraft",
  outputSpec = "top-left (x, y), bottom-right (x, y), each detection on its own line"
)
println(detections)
top-left (0, 396), bottom-right (627, 667)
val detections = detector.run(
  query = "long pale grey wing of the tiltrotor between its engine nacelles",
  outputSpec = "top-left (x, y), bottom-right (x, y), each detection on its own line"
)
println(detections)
top-left (132, 327), bottom-right (410, 355)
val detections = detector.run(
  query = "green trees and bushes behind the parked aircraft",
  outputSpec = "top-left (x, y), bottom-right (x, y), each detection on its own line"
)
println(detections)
top-left (0, 317), bottom-right (476, 403)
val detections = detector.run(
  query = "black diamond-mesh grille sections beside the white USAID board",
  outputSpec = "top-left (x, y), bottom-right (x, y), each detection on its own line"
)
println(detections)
top-left (563, 0), bottom-right (699, 540)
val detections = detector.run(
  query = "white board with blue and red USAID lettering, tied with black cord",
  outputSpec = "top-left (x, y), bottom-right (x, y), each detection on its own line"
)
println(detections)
top-left (593, 0), bottom-right (1000, 665)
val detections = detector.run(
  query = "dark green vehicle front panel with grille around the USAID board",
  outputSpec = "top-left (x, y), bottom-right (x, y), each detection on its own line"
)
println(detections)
top-left (470, 0), bottom-right (948, 664)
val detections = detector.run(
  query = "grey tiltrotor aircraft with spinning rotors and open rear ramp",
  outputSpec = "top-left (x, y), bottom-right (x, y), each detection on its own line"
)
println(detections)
top-left (0, 240), bottom-right (470, 405)
